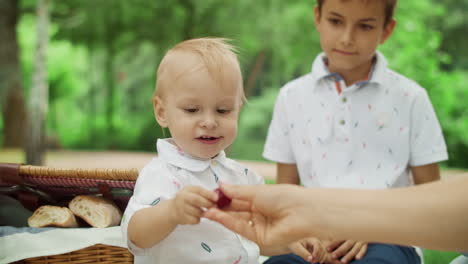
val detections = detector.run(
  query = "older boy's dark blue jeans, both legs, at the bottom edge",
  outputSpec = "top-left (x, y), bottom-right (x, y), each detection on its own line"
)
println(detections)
top-left (263, 244), bottom-right (421, 264)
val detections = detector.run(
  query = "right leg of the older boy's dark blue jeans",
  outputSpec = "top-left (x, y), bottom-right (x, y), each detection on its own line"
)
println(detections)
top-left (351, 244), bottom-right (421, 264)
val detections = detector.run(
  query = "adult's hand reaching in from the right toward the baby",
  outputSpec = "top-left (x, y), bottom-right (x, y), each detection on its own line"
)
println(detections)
top-left (204, 184), bottom-right (324, 253)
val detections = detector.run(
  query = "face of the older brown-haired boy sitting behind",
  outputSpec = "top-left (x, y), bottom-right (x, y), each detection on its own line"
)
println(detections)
top-left (315, 0), bottom-right (395, 73)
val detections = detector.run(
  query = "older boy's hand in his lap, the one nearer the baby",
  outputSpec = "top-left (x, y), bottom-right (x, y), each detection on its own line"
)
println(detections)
top-left (289, 237), bottom-right (339, 263)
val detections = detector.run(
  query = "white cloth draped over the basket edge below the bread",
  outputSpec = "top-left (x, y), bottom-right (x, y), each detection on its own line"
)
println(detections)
top-left (0, 226), bottom-right (126, 263)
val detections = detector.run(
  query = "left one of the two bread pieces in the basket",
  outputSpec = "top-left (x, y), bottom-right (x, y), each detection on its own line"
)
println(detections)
top-left (28, 205), bottom-right (78, 227)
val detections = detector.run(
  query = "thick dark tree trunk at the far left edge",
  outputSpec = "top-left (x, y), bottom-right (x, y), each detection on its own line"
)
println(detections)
top-left (0, 0), bottom-right (26, 148)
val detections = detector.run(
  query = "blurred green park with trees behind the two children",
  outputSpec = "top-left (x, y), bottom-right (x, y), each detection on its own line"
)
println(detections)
top-left (0, 0), bottom-right (468, 263)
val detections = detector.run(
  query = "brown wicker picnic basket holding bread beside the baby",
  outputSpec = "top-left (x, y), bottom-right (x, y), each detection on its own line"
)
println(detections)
top-left (0, 163), bottom-right (138, 264)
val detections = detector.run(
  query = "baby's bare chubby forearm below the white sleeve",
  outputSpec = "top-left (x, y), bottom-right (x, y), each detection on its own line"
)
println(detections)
top-left (128, 200), bottom-right (177, 248)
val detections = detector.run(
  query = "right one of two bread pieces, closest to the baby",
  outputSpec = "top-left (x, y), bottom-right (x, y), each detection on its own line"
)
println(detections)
top-left (68, 195), bottom-right (122, 228)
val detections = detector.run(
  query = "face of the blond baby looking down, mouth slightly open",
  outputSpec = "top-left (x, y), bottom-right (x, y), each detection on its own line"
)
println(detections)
top-left (156, 65), bottom-right (241, 159)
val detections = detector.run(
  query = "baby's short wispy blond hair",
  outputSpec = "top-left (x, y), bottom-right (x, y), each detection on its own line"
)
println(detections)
top-left (155, 38), bottom-right (245, 102)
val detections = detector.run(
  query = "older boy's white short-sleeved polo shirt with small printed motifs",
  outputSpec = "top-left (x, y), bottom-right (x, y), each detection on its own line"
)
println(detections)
top-left (263, 53), bottom-right (448, 189)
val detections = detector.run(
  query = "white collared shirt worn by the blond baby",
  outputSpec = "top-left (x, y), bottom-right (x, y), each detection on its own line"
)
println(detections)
top-left (121, 139), bottom-right (263, 264)
